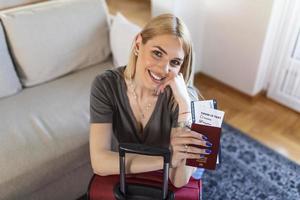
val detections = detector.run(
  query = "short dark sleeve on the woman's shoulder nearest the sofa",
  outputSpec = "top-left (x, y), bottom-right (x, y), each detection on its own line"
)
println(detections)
top-left (90, 75), bottom-right (113, 123)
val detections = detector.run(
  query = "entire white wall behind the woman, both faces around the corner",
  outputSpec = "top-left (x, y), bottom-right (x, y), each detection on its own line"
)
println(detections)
top-left (152, 0), bottom-right (273, 95)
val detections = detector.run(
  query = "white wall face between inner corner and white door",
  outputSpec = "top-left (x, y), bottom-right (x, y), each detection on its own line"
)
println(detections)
top-left (201, 0), bottom-right (273, 95)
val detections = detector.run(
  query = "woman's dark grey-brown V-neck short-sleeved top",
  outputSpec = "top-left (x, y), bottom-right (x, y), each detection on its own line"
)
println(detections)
top-left (90, 67), bottom-right (195, 151)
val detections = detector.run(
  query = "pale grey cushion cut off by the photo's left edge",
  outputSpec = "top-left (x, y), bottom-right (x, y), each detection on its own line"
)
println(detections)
top-left (0, 22), bottom-right (22, 98)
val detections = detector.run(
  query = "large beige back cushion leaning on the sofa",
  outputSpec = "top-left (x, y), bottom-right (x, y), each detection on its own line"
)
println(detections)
top-left (0, 0), bottom-right (110, 86)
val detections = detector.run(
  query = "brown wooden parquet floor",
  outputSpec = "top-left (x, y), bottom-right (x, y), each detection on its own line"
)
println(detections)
top-left (107, 0), bottom-right (300, 164)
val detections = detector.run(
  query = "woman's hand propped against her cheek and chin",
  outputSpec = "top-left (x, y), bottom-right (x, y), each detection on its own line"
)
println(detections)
top-left (157, 71), bottom-right (190, 105)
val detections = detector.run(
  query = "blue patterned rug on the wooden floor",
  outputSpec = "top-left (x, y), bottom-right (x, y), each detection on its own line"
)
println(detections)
top-left (203, 124), bottom-right (300, 200)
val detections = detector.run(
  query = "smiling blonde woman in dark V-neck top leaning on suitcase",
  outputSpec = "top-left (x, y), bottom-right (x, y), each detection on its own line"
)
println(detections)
top-left (90, 14), bottom-right (211, 187)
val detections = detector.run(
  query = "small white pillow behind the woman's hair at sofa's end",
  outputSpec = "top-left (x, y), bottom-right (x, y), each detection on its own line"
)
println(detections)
top-left (110, 13), bottom-right (141, 67)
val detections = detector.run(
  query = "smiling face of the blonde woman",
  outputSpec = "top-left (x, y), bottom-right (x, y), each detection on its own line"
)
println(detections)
top-left (135, 35), bottom-right (184, 90)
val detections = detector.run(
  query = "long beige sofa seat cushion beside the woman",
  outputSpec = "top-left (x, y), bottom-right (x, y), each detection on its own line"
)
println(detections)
top-left (0, 59), bottom-right (113, 199)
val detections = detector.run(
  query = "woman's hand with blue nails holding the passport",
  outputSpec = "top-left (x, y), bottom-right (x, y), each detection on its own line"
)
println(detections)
top-left (170, 128), bottom-right (212, 168)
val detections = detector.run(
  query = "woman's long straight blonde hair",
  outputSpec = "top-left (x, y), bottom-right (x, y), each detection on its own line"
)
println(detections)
top-left (124, 14), bottom-right (194, 86)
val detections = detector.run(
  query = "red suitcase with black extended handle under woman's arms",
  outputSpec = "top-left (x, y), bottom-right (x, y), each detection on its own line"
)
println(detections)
top-left (88, 144), bottom-right (202, 200)
